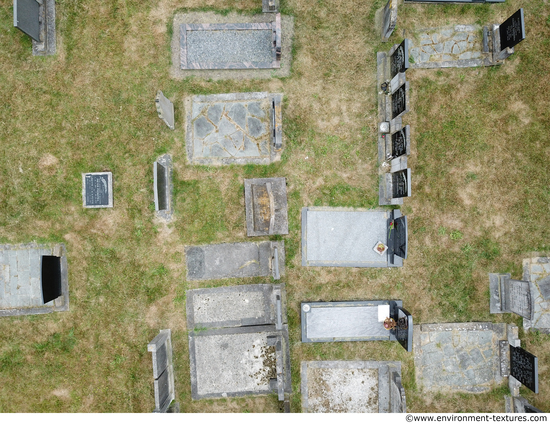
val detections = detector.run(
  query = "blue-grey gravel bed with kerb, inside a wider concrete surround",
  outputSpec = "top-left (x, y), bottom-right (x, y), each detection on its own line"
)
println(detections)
top-left (180, 22), bottom-right (280, 69)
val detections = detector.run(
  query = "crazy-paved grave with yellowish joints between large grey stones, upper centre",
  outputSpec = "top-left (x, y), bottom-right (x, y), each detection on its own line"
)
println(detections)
top-left (185, 92), bottom-right (283, 165)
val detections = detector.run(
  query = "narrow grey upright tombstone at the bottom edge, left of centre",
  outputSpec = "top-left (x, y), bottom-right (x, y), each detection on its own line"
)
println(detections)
top-left (147, 330), bottom-right (176, 412)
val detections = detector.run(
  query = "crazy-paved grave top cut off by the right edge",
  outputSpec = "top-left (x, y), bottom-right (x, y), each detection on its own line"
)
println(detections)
top-left (522, 257), bottom-right (550, 334)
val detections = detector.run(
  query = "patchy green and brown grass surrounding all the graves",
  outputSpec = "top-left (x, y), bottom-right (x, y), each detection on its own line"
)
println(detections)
top-left (0, 0), bottom-right (550, 412)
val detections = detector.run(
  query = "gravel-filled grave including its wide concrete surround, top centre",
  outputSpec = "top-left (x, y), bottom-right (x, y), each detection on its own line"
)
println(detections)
top-left (171, 12), bottom-right (294, 79)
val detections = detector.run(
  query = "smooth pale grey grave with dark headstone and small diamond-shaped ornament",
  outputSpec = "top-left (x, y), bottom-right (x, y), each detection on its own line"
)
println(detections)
top-left (302, 207), bottom-right (407, 268)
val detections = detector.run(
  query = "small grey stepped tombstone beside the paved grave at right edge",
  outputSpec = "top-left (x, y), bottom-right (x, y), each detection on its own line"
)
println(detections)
top-left (489, 274), bottom-right (533, 320)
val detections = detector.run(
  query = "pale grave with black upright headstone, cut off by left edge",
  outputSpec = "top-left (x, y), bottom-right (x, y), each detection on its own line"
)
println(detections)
top-left (0, 243), bottom-right (69, 316)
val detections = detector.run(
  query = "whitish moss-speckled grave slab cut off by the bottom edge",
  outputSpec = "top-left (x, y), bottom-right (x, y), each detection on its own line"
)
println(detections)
top-left (301, 361), bottom-right (406, 413)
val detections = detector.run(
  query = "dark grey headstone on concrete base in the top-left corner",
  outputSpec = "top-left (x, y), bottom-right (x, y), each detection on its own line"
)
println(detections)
top-left (13, 0), bottom-right (56, 56)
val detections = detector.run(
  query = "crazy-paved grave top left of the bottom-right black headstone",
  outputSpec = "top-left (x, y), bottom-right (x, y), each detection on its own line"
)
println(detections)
top-left (414, 322), bottom-right (517, 393)
